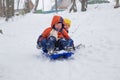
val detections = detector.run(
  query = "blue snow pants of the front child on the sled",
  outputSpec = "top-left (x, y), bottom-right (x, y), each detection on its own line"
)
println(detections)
top-left (37, 36), bottom-right (73, 53)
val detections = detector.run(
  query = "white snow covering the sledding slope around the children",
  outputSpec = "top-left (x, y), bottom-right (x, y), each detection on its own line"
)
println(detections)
top-left (0, 3), bottom-right (120, 80)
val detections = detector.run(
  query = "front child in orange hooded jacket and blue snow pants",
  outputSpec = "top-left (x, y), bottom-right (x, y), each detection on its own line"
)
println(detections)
top-left (37, 16), bottom-right (73, 53)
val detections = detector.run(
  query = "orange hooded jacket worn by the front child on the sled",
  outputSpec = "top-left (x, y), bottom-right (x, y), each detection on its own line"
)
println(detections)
top-left (39, 16), bottom-right (70, 41)
